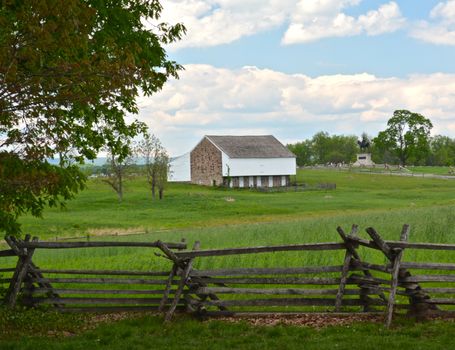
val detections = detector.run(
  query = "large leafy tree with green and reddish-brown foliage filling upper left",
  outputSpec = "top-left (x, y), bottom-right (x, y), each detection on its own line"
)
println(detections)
top-left (0, 0), bottom-right (185, 234)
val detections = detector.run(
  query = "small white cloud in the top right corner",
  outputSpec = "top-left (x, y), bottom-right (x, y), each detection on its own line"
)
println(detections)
top-left (410, 0), bottom-right (455, 45)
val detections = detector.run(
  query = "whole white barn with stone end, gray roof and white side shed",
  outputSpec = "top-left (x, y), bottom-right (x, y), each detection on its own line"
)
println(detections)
top-left (170, 135), bottom-right (296, 187)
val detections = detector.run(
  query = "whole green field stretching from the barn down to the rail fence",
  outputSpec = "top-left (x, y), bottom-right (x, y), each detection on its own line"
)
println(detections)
top-left (7, 170), bottom-right (455, 269)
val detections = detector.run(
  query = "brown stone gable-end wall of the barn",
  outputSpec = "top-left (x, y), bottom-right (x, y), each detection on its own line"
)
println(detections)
top-left (190, 138), bottom-right (223, 186)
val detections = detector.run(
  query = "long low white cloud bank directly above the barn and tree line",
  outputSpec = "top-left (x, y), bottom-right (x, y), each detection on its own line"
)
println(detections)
top-left (140, 65), bottom-right (455, 155)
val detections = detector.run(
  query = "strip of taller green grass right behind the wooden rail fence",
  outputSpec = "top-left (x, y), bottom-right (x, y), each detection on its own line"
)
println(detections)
top-left (14, 206), bottom-right (455, 270)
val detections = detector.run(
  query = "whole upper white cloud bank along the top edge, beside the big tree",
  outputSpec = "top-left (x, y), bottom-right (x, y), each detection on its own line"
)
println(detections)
top-left (161, 0), bottom-right (405, 49)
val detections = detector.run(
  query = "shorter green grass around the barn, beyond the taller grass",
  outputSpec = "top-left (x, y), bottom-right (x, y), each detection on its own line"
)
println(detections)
top-left (17, 170), bottom-right (455, 239)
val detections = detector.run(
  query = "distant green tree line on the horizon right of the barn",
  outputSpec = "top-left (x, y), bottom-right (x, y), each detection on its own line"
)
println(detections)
top-left (287, 110), bottom-right (455, 166)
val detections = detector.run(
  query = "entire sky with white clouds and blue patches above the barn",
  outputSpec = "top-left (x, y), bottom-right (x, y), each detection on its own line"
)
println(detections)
top-left (139, 0), bottom-right (455, 155)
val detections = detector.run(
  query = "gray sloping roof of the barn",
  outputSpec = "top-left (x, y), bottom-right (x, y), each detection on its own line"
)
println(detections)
top-left (206, 135), bottom-right (295, 158)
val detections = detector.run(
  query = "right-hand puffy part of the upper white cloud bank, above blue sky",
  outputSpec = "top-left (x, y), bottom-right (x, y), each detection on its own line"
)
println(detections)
top-left (282, 0), bottom-right (406, 44)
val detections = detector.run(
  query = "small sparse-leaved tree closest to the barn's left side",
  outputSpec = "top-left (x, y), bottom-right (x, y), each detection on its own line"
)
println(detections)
top-left (136, 132), bottom-right (169, 199)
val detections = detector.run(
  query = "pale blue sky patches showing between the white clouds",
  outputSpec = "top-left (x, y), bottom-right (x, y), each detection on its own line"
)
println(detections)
top-left (170, 0), bottom-right (455, 76)
